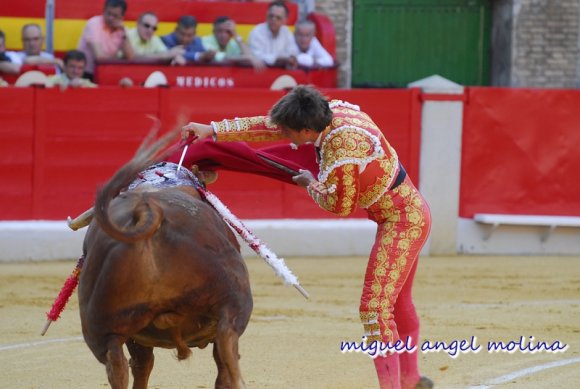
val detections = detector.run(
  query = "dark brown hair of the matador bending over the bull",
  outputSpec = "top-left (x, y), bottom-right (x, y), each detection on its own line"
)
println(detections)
top-left (270, 85), bottom-right (332, 132)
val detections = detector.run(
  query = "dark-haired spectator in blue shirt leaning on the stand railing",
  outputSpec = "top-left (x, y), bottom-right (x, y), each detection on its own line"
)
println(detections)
top-left (161, 15), bottom-right (215, 65)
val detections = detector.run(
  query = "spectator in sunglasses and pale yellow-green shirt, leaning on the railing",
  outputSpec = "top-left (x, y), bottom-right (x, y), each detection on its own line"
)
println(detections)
top-left (127, 12), bottom-right (185, 62)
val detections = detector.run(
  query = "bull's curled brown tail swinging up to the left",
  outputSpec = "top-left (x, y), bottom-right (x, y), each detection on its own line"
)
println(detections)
top-left (95, 124), bottom-right (179, 243)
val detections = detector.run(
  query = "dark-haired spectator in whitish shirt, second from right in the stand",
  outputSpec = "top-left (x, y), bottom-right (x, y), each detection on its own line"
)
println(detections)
top-left (249, 0), bottom-right (298, 68)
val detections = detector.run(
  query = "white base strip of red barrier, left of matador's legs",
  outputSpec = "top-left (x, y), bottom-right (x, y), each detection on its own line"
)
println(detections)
top-left (0, 219), bottom-right (377, 261)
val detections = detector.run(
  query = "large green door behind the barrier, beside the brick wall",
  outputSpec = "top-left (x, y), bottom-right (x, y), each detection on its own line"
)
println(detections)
top-left (352, 0), bottom-right (491, 87)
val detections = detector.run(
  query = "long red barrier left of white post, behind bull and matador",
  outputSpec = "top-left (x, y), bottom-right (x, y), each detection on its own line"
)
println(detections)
top-left (0, 87), bottom-right (420, 220)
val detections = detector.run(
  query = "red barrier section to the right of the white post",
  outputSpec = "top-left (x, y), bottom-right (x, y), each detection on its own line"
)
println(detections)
top-left (459, 88), bottom-right (580, 218)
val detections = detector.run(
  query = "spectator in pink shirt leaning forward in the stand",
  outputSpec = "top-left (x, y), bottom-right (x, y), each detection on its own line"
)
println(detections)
top-left (78, 0), bottom-right (134, 80)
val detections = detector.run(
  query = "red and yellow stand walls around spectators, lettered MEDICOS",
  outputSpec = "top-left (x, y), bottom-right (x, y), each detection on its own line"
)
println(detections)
top-left (0, 0), bottom-right (336, 88)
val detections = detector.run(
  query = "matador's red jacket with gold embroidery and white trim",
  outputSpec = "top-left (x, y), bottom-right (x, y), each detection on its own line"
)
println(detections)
top-left (211, 100), bottom-right (399, 216)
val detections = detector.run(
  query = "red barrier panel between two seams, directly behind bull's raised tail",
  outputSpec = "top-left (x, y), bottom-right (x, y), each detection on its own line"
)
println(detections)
top-left (33, 88), bottom-right (159, 219)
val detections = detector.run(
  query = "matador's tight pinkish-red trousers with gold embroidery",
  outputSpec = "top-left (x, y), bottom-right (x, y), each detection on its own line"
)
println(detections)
top-left (359, 177), bottom-right (431, 344)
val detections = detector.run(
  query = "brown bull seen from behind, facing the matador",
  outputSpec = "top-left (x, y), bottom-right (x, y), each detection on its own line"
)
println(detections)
top-left (78, 131), bottom-right (252, 389)
